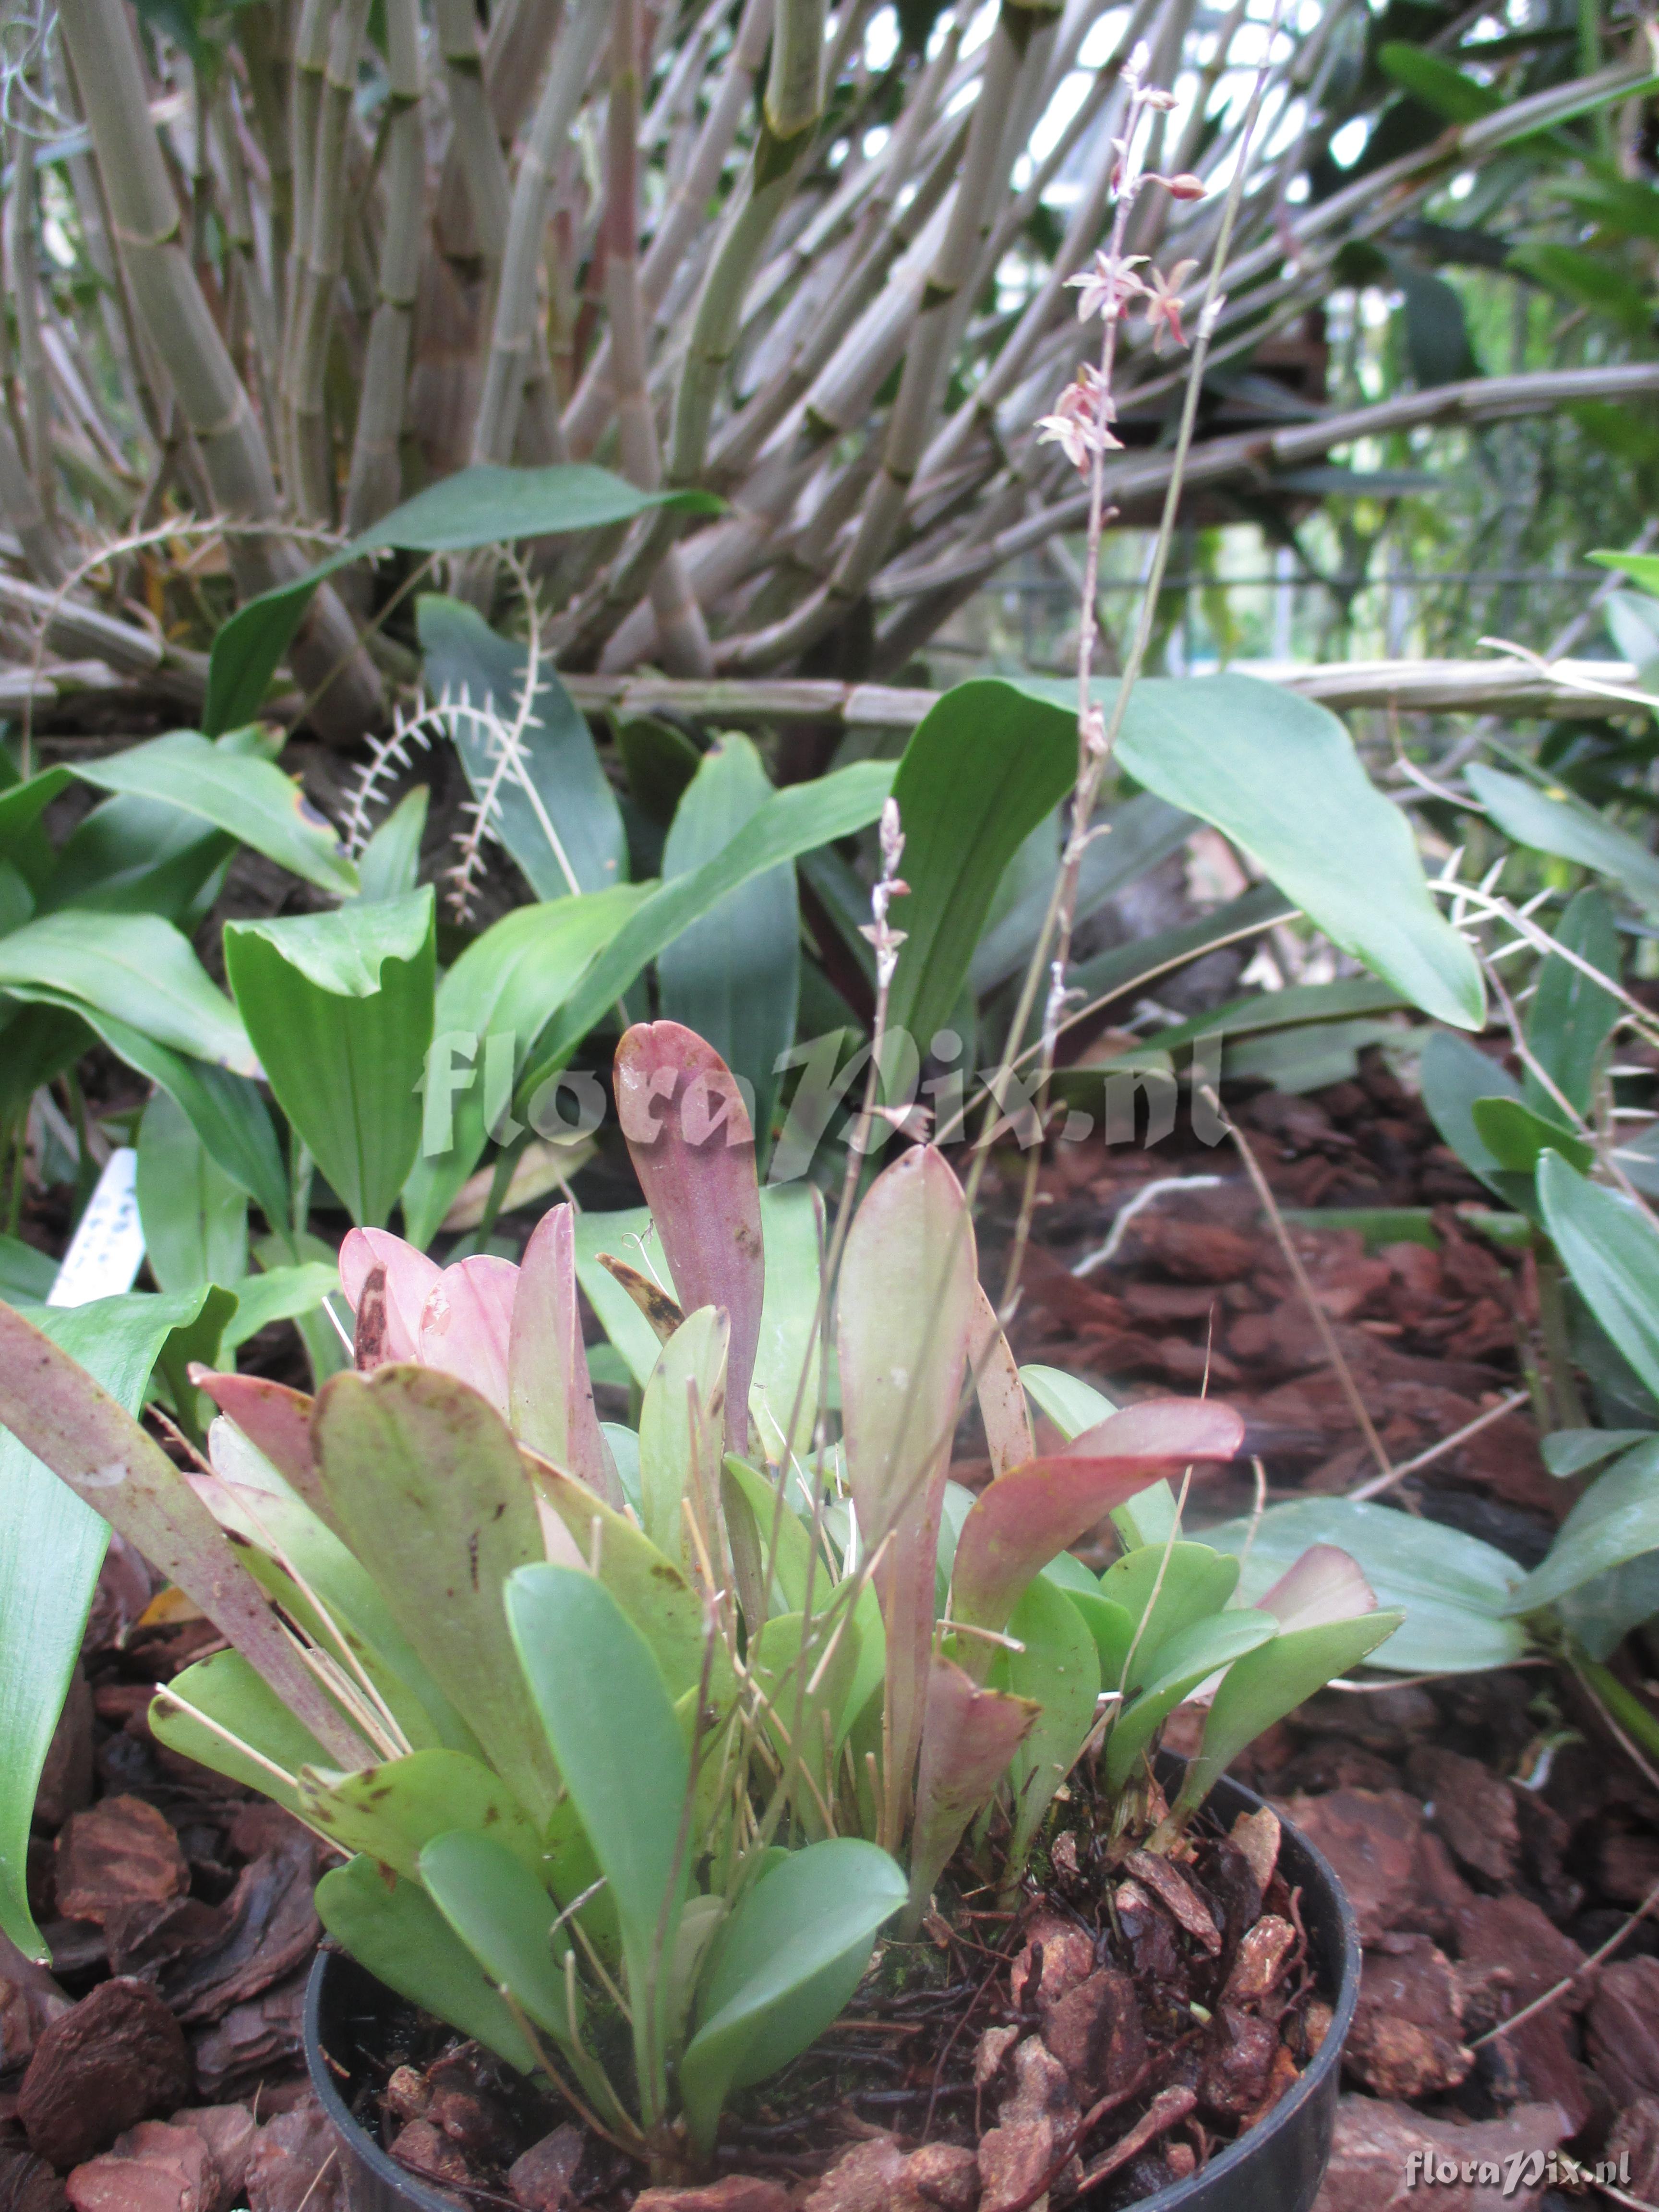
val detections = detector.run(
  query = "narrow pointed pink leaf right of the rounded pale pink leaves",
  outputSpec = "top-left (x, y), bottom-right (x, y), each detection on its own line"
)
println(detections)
top-left (506, 1205), bottom-right (622, 1511)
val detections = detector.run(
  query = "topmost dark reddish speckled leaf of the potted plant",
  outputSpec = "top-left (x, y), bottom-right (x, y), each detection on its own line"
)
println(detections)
top-left (615, 1022), bottom-right (765, 1455)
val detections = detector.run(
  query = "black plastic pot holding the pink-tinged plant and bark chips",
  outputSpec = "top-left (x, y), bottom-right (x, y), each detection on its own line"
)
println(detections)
top-left (305, 1776), bottom-right (1360, 2212)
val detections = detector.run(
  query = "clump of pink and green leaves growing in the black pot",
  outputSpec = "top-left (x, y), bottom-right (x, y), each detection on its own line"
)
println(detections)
top-left (0, 1022), bottom-right (1400, 2172)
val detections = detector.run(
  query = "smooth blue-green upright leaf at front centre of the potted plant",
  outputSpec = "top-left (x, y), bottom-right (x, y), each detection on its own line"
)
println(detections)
top-left (506, 1564), bottom-right (690, 2119)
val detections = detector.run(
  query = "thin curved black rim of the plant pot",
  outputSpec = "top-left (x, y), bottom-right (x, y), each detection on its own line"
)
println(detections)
top-left (305, 1774), bottom-right (1360, 2212)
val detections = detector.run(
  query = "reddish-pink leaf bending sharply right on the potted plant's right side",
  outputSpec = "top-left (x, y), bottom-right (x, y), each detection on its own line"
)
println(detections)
top-left (951, 1398), bottom-right (1243, 1672)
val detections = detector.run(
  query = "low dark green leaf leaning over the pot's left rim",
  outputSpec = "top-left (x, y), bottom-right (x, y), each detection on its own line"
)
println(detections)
top-left (316, 1856), bottom-right (535, 2073)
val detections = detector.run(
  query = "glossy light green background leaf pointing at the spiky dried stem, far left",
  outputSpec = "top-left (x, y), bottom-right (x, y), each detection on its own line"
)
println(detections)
top-left (75, 730), bottom-right (358, 898)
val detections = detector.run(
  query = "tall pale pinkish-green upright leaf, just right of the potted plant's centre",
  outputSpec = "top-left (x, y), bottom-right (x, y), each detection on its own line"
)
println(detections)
top-left (836, 1146), bottom-right (978, 1840)
